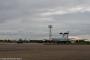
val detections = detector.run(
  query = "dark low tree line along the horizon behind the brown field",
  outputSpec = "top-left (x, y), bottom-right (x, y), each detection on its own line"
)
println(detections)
top-left (0, 39), bottom-right (90, 45)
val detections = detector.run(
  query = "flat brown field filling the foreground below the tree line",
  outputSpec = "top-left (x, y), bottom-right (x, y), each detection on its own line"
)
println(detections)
top-left (0, 43), bottom-right (90, 60)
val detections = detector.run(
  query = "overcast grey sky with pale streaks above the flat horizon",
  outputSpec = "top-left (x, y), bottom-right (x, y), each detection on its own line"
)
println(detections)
top-left (0, 0), bottom-right (90, 39)
